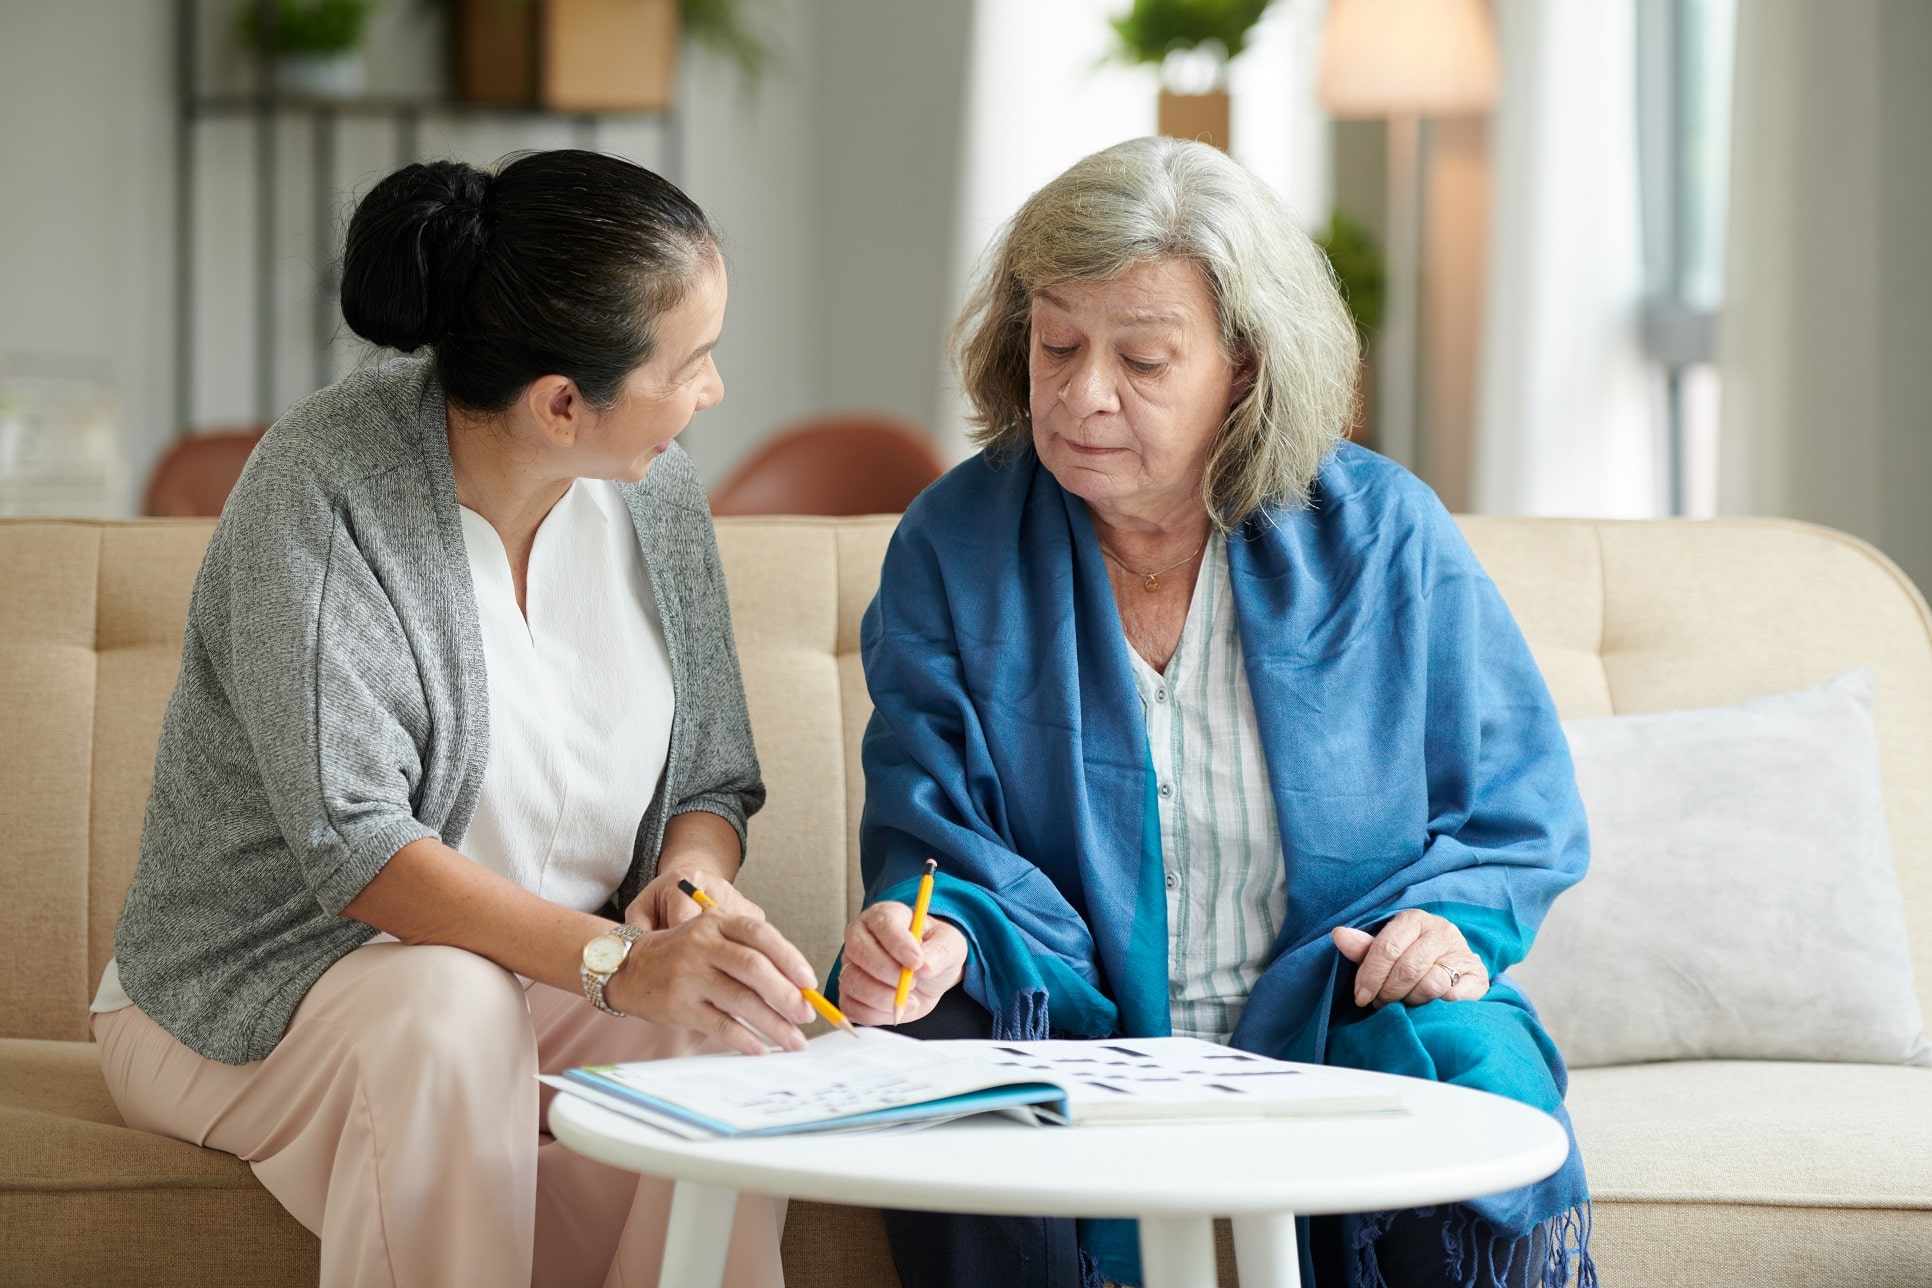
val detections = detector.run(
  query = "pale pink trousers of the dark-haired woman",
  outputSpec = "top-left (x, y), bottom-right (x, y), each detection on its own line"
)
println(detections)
top-left (93, 942), bottom-right (784, 1288)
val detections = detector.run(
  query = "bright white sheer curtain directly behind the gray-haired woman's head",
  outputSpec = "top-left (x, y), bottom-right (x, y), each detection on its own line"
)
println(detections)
top-left (933, 0), bottom-right (1331, 458)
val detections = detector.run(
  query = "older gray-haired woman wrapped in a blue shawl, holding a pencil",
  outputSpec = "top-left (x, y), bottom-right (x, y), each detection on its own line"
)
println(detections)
top-left (838, 139), bottom-right (1594, 1288)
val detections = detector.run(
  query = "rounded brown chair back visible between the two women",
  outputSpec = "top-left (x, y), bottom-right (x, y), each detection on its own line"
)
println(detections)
top-left (711, 413), bottom-right (945, 516)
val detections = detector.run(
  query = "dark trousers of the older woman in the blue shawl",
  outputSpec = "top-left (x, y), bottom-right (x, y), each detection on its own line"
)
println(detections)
top-left (885, 989), bottom-right (1544, 1288)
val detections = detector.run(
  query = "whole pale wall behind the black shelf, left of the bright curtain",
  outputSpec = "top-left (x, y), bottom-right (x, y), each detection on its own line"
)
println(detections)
top-left (0, 0), bottom-right (972, 510)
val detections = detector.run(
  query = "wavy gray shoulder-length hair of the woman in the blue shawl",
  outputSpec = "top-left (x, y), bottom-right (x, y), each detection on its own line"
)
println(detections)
top-left (951, 139), bottom-right (1360, 531)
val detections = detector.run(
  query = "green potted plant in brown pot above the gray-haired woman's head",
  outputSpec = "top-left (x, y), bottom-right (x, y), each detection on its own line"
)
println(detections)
top-left (1113, 0), bottom-right (1273, 151)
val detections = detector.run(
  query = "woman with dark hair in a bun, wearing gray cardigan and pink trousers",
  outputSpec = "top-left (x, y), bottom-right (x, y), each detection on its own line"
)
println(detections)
top-left (93, 151), bottom-right (813, 1288)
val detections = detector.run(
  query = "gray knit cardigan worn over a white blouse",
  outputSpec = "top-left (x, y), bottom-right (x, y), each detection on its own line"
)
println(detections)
top-left (114, 357), bottom-right (765, 1064)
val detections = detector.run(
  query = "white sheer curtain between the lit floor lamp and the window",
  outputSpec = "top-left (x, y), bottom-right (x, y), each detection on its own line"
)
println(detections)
top-left (1472, 0), bottom-right (1665, 518)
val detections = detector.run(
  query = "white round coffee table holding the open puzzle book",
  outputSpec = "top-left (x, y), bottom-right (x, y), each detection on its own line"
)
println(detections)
top-left (551, 1070), bottom-right (1569, 1288)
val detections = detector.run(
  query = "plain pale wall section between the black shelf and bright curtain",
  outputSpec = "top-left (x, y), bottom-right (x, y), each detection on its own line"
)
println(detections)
top-left (684, 0), bottom-right (974, 481)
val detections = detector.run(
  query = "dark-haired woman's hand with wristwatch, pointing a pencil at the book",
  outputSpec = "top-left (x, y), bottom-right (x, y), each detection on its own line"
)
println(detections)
top-left (605, 911), bottom-right (817, 1056)
